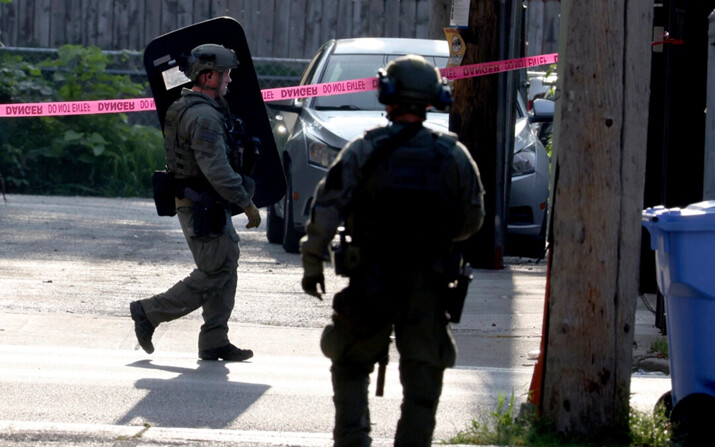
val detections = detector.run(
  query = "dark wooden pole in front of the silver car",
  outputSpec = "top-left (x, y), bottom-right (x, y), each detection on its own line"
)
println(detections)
top-left (449, 0), bottom-right (504, 269)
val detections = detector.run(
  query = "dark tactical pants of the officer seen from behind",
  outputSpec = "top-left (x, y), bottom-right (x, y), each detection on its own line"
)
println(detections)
top-left (321, 277), bottom-right (456, 447)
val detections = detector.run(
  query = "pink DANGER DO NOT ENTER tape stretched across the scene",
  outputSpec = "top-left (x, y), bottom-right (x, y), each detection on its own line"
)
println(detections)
top-left (0, 53), bottom-right (559, 118)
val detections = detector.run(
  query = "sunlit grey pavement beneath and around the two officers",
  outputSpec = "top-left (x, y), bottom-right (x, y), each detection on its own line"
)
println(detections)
top-left (0, 195), bottom-right (670, 446)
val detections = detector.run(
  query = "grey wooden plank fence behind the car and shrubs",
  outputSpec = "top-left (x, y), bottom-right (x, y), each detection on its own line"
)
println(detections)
top-left (0, 0), bottom-right (560, 58)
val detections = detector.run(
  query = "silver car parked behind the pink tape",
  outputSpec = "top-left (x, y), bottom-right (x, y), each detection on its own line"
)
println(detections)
top-left (266, 38), bottom-right (549, 254)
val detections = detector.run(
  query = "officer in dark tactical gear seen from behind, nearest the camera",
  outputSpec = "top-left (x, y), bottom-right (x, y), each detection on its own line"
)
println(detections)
top-left (301, 55), bottom-right (484, 447)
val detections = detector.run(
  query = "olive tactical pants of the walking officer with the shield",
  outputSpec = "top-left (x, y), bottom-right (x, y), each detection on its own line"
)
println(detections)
top-left (141, 206), bottom-right (239, 350)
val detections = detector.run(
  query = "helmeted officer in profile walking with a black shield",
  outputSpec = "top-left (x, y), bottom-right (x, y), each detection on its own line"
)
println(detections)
top-left (130, 44), bottom-right (261, 361)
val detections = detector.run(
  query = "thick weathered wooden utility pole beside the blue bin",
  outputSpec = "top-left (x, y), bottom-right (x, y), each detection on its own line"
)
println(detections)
top-left (538, 0), bottom-right (653, 436)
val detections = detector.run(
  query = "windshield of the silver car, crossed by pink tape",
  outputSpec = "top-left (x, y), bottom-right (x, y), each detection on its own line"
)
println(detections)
top-left (313, 54), bottom-right (448, 111)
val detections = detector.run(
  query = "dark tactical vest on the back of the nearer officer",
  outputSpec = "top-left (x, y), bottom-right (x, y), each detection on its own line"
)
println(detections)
top-left (348, 128), bottom-right (457, 263)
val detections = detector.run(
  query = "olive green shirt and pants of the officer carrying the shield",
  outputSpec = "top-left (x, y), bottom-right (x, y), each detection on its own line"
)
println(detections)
top-left (140, 89), bottom-right (252, 351)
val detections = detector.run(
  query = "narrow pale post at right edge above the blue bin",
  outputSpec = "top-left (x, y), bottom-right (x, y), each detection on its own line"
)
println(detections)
top-left (703, 10), bottom-right (715, 200)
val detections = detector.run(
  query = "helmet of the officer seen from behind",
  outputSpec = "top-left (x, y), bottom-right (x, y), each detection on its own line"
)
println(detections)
top-left (377, 54), bottom-right (452, 110)
